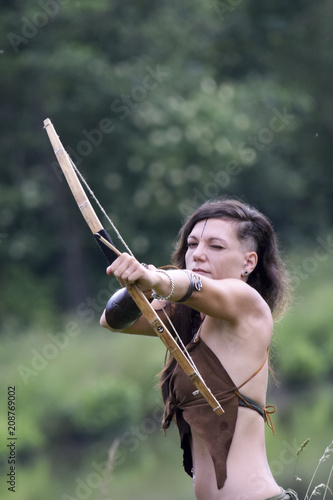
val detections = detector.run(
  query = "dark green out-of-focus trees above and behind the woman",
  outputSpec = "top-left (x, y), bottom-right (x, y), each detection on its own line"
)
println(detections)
top-left (0, 0), bottom-right (333, 327)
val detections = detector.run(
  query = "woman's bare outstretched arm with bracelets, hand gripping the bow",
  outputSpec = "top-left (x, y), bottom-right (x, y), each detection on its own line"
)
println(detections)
top-left (101, 254), bottom-right (268, 335)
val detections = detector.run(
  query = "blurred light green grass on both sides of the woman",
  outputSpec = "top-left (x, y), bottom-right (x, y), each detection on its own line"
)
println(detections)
top-left (0, 260), bottom-right (333, 500)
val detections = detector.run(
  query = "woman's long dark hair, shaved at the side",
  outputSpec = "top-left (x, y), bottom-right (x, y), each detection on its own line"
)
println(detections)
top-left (161, 199), bottom-right (290, 427)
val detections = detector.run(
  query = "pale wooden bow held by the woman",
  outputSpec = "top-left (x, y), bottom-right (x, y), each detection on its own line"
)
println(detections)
top-left (44, 118), bottom-right (224, 415)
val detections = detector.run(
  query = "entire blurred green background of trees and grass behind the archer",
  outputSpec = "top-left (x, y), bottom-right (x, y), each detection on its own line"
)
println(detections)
top-left (0, 0), bottom-right (333, 500)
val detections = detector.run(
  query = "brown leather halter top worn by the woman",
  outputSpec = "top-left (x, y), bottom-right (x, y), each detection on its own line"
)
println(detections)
top-left (164, 337), bottom-right (265, 489)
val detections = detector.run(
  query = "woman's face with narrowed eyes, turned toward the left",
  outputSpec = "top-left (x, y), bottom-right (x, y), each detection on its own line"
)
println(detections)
top-left (185, 219), bottom-right (257, 279)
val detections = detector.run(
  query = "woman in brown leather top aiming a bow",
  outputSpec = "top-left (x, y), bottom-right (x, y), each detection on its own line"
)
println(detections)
top-left (101, 200), bottom-right (297, 500)
